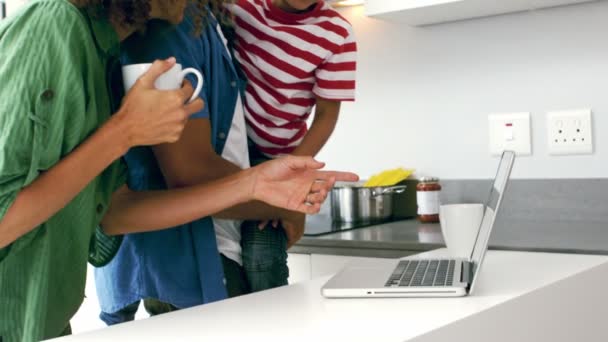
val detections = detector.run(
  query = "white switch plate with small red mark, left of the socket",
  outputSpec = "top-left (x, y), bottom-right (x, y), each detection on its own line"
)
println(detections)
top-left (488, 112), bottom-right (532, 156)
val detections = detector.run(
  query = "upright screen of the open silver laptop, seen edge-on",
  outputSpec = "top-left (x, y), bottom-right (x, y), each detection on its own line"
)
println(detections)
top-left (471, 151), bottom-right (515, 288)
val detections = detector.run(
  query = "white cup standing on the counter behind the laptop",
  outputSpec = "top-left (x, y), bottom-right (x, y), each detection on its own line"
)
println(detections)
top-left (439, 203), bottom-right (484, 259)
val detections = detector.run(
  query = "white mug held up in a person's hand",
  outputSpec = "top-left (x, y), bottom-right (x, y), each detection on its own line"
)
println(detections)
top-left (122, 63), bottom-right (203, 102)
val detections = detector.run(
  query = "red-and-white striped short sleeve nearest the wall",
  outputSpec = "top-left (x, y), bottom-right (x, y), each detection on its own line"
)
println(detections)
top-left (313, 25), bottom-right (357, 101)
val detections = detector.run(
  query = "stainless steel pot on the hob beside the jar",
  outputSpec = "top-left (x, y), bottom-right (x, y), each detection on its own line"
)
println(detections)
top-left (330, 185), bottom-right (406, 223)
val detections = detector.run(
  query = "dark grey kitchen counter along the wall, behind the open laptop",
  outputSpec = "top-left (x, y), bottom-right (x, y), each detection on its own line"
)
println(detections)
top-left (289, 207), bottom-right (608, 258)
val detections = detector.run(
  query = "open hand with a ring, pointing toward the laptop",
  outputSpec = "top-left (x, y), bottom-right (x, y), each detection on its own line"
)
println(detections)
top-left (250, 156), bottom-right (359, 214)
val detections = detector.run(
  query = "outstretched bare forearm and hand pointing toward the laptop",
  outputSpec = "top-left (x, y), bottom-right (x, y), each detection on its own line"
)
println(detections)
top-left (101, 156), bottom-right (358, 234)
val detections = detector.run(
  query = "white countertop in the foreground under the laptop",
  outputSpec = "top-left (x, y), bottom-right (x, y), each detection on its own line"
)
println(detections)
top-left (53, 249), bottom-right (608, 342)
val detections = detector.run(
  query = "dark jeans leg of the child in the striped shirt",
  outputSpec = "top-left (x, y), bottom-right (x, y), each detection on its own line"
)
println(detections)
top-left (241, 221), bottom-right (289, 292)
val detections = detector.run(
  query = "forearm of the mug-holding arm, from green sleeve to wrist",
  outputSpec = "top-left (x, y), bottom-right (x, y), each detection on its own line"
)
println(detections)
top-left (0, 119), bottom-right (128, 248)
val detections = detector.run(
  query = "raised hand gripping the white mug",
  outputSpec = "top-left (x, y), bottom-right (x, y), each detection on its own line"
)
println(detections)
top-left (114, 58), bottom-right (203, 147)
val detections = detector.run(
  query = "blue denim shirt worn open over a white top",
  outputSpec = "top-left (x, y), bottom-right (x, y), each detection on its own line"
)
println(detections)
top-left (95, 13), bottom-right (243, 313)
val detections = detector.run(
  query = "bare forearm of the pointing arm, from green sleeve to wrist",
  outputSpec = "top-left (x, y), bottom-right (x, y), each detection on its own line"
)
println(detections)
top-left (102, 170), bottom-right (255, 235)
